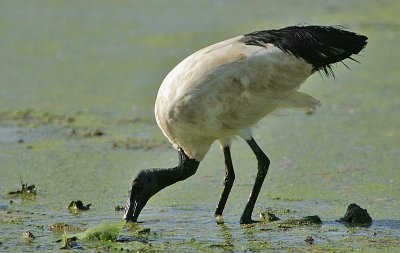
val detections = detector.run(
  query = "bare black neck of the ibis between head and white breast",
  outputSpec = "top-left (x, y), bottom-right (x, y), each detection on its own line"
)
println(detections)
top-left (156, 150), bottom-right (200, 190)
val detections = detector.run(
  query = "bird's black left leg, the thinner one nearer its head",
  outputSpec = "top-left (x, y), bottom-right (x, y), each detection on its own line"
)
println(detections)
top-left (215, 146), bottom-right (235, 217)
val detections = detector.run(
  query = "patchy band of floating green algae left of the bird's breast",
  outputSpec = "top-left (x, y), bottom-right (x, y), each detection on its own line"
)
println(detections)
top-left (0, 109), bottom-right (170, 150)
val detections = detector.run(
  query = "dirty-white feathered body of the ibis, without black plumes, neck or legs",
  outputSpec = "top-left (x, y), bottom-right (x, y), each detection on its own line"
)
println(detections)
top-left (155, 36), bottom-right (320, 161)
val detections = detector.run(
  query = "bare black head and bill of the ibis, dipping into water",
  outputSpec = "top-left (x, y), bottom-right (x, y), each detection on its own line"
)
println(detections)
top-left (124, 169), bottom-right (160, 222)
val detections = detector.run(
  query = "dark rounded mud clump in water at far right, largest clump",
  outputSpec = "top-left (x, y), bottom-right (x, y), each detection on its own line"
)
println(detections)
top-left (339, 203), bottom-right (372, 226)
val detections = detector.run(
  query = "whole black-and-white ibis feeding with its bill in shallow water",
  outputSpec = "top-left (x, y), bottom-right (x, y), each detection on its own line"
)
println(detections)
top-left (124, 26), bottom-right (367, 224)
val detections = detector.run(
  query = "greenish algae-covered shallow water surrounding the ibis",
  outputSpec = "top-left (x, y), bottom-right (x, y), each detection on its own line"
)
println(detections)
top-left (0, 1), bottom-right (400, 252)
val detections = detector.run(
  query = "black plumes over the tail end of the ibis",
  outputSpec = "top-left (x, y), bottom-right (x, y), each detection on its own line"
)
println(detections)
top-left (244, 26), bottom-right (368, 76)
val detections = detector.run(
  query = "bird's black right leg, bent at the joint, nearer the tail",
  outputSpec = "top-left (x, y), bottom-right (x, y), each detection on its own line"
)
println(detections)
top-left (240, 138), bottom-right (270, 224)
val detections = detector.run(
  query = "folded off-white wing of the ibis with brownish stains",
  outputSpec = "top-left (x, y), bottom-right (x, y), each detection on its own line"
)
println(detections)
top-left (169, 37), bottom-right (319, 131)
